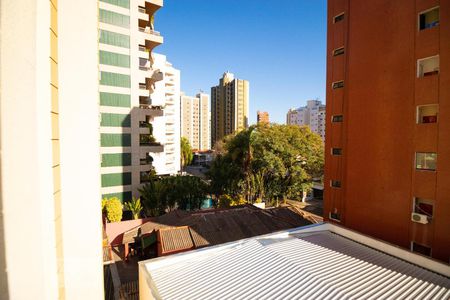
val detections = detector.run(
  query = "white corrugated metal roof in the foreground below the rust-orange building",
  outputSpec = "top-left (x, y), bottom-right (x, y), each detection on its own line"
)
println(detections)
top-left (145, 231), bottom-right (450, 299)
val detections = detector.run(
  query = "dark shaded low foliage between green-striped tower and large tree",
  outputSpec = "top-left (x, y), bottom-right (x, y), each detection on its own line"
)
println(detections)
top-left (139, 176), bottom-right (209, 216)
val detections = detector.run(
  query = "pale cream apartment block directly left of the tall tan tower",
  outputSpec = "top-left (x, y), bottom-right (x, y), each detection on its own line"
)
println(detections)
top-left (181, 93), bottom-right (211, 151)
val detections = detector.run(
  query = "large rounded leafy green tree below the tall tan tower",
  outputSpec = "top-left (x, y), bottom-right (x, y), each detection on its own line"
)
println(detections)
top-left (208, 125), bottom-right (324, 203)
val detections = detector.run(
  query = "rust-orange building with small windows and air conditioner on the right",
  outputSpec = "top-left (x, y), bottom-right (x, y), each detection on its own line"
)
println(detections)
top-left (325, 0), bottom-right (450, 263)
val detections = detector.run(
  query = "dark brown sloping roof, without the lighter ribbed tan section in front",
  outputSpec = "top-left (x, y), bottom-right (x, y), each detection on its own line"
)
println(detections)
top-left (123, 205), bottom-right (312, 248)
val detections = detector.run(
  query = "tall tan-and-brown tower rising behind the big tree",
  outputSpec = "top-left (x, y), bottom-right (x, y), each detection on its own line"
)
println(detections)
top-left (211, 72), bottom-right (249, 146)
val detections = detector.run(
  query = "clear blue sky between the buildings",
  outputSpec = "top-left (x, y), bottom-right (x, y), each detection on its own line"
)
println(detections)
top-left (155, 0), bottom-right (326, 123)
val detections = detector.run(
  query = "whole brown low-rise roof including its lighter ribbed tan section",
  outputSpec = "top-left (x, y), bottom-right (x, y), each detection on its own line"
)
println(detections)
top-left (116, 205), bottom-right (315, 256)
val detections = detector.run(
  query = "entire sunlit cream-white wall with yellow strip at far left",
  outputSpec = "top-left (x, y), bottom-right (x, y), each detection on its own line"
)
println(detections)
top-left (0, 0), bottom-right (103, 299)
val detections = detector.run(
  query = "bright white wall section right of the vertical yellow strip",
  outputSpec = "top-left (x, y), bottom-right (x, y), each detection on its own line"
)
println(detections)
top-left (58, 0), bottom-right (104, 299)
